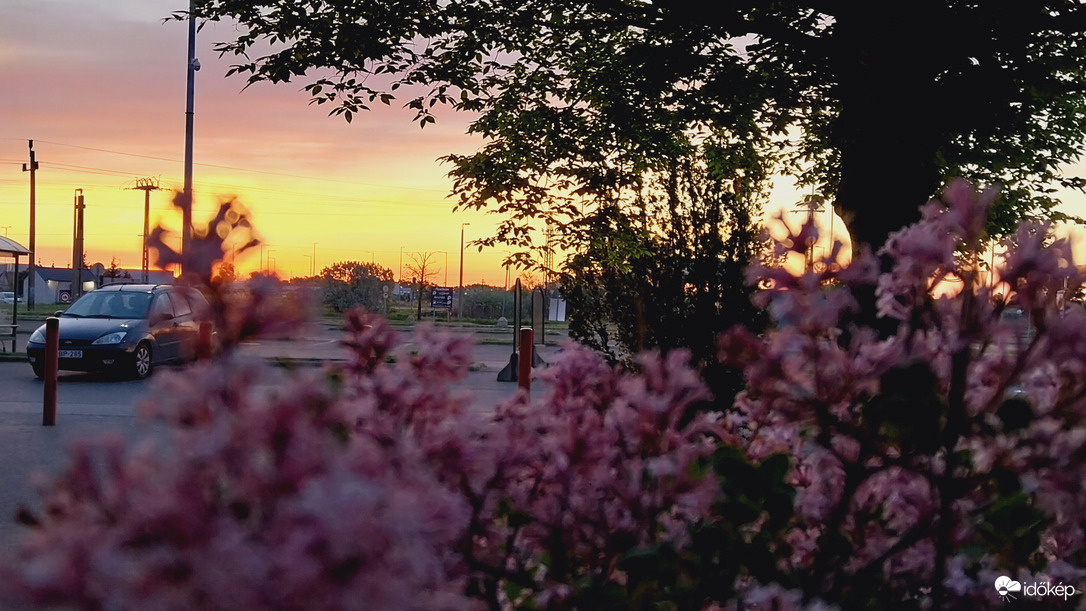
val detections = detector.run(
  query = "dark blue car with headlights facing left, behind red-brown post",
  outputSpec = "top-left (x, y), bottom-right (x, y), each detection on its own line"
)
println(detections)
top-left (26, 284), bottom-right (210, 379)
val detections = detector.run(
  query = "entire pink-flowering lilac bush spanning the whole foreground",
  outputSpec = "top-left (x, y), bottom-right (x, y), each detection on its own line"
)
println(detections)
top-left (0, 182), bottom-right (1086, 610)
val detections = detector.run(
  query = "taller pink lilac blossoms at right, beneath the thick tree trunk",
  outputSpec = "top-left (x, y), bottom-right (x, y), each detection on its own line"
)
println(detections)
top-left (719, 181), bottom-right (1086, 607)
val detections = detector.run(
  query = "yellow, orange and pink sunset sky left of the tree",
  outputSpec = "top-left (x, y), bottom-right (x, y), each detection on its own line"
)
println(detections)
top-left (6, 0), bottom-right (1086, 285)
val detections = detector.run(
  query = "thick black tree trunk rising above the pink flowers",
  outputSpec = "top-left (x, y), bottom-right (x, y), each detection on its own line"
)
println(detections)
top-left (831, 0), bottom-right (946, 251)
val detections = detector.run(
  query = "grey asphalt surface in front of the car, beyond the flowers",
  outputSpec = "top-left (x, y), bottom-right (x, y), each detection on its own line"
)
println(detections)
top-left (0, 329), bottom-right (559, 553)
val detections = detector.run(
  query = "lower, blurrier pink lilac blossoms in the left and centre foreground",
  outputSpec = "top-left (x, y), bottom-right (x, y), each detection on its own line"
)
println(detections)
top-left (0, 310), bottom-right (719, 610)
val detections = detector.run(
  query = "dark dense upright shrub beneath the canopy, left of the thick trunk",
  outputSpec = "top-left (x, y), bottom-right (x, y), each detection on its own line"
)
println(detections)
top-left (561, 137), bottom-right (768, 400)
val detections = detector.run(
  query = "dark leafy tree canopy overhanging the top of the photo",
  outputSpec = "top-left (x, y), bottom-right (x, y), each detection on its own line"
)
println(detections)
top-left (188, 0), bottom-right (1086, 246)
